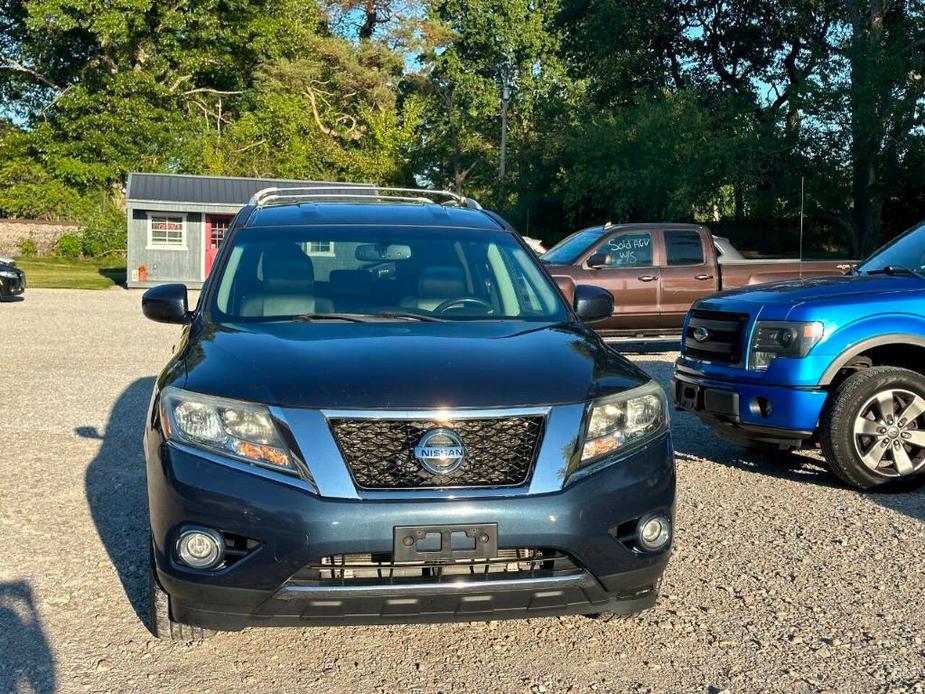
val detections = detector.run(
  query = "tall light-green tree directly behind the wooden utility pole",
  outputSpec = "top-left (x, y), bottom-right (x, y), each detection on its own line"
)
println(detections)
top-left (408, 0), bottom-right (560, 207)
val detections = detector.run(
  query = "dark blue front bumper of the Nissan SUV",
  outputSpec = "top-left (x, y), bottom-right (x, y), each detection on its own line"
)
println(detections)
top-left (146, 434), bottom-right (675, 629)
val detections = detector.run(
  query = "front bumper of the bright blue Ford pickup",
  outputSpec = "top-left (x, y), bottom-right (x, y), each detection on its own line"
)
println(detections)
top-left (670, 366), bottom-right (828, 445)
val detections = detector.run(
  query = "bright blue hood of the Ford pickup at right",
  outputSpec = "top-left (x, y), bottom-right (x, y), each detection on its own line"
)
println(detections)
top-left (698, 275), bottom-right (925, 309)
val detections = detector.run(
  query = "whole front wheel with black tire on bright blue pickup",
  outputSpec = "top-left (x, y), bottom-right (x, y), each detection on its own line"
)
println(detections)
top-left (820, 366), bottom-right (925, 489)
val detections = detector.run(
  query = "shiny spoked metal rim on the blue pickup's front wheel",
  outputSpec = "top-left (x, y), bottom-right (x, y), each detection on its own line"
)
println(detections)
top-left (854, 389), bottom-right (925, 477)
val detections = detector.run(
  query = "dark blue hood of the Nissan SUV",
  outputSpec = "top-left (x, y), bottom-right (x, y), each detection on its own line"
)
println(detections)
top-left (178, 321), bottom-right (649, 409)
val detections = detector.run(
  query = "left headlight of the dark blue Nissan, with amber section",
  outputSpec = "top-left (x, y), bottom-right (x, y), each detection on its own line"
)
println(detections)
top-left (161, 388), bottom-right (298, 472)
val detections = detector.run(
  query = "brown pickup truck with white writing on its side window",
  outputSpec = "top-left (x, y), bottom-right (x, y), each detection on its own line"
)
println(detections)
top-left (541, 224), bottom-right (851, 336)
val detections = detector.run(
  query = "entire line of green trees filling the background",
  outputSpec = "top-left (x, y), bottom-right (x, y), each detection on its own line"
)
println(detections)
top-left (0, 0), bottom-right (925, 255)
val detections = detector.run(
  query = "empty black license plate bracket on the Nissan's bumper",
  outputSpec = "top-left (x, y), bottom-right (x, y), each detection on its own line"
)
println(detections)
top-left (392, 523), bottom-right (498, 561)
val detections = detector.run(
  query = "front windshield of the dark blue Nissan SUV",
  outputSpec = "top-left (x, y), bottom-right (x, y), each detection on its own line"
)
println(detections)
top-left (210, 226), bottom-right (568, 322)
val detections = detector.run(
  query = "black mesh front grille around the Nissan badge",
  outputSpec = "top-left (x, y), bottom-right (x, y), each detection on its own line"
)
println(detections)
top-left (329, 416), bottom-right (545, 489)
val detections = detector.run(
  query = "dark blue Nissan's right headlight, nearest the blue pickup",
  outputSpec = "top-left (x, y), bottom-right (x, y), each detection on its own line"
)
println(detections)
top-left (579, 381), bottom-right (668, 467)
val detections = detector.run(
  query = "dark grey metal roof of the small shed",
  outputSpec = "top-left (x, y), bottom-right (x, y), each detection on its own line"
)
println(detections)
top-left (126, 173), bottom-right (373, 206)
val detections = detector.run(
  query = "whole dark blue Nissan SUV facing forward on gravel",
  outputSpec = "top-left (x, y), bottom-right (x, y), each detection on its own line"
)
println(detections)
top-left (143, 189), bottom-right (675, 639)
